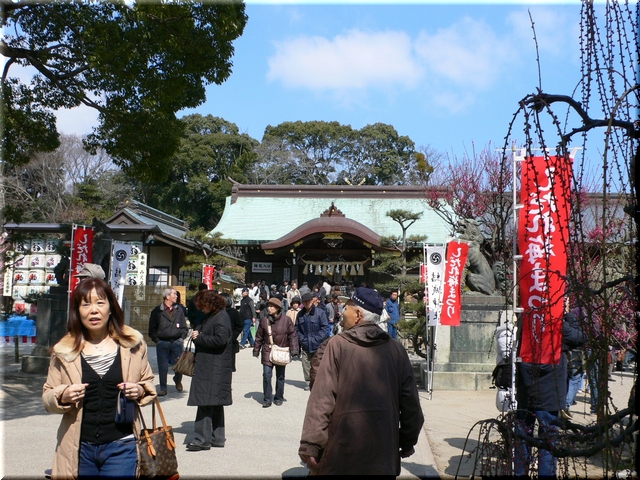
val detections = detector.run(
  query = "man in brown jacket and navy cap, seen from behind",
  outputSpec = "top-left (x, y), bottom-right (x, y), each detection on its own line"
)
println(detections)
top-left (298, 288), bottom-right (424, 476)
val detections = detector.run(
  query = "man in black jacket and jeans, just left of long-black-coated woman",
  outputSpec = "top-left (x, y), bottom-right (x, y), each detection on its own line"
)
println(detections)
top-left (149, 288), bottom-right (189, 397)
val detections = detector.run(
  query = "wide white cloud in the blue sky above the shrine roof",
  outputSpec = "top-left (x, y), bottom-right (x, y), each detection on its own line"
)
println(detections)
top-left (267, 17), bottom-right (520, 112)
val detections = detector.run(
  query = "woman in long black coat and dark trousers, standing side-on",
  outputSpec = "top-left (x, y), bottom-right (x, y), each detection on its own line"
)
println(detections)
top-left (187, 290), bottom-right (233, 451)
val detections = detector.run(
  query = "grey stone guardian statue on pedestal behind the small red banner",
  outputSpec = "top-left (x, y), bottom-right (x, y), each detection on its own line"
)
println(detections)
top-left (456, 218), bottom-right (496, 295)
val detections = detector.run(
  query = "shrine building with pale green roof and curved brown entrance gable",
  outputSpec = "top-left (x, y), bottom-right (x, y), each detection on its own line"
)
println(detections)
top-left (211, 183), bottom-right (451, 286)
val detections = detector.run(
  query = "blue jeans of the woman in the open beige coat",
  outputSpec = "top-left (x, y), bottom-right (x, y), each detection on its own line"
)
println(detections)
top-left (78, 436), bottom-right (138, 478)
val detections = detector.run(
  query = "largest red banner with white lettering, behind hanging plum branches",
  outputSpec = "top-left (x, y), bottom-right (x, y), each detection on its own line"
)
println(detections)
top-left (518, 156), bottom-right (572, 365)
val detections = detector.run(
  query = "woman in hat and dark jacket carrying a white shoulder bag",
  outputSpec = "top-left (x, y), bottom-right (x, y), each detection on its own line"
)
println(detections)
top-left (253, 297), bottom-right (300, 408)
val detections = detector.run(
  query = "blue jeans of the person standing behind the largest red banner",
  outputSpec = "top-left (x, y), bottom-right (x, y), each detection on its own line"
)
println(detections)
top-left (514, 410), bottom-right (558, 477)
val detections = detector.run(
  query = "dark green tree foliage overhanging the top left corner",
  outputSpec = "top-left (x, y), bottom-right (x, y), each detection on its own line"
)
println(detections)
top-left (0, 1), bottom-right (247, 180)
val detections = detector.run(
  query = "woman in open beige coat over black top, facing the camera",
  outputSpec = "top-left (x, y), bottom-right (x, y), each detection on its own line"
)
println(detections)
top-left (42, 278), bottom-right (156, 478)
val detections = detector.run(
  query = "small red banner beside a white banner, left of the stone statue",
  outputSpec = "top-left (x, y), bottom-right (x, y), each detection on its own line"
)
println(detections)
top-left (440, 240), bottom-right (469, 327)
